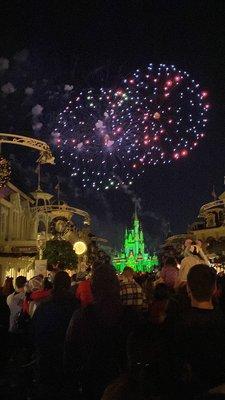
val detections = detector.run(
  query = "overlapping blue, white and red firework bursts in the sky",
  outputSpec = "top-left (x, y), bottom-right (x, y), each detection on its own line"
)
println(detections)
top-left (53, 64), bottom-right (209, 190)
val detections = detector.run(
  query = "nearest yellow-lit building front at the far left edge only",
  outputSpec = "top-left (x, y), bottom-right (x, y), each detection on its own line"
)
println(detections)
top-left (0, 183), bottom-right (37, 281)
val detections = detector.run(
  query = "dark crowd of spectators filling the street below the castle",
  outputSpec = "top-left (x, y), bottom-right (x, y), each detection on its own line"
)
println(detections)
top-left (0, 243), bottom-right (225, 400)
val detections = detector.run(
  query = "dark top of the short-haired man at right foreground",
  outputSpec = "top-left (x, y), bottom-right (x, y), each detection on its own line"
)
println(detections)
top-left (175, 307), bottom-right (225, 392)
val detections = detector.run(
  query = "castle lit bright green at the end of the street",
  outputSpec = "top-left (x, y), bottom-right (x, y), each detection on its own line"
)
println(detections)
top-left (113, 212), bottom-right (158, 272)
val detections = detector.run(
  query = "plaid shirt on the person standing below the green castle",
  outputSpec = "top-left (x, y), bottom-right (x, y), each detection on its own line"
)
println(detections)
top-left (120, 280), bottom-right (146, 309)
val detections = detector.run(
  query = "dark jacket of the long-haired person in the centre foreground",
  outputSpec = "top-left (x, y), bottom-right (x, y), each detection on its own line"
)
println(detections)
top-left (65, 304), bottom-right (137, 400)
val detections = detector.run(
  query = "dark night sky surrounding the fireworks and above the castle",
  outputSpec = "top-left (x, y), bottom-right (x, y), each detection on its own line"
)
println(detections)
top-left (0, 0), bottom-right (225, 248)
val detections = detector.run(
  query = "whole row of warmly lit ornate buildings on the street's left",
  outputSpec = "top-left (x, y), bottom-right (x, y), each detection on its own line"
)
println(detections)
top-left (0, 182), bottom-right (90, 282)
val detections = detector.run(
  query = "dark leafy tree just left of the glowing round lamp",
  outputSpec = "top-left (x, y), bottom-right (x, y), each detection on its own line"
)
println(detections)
top-left (43, 240), bottom-right (77, 269)
